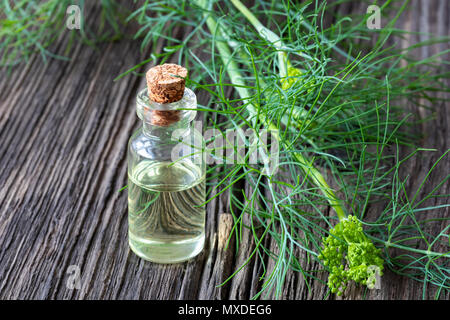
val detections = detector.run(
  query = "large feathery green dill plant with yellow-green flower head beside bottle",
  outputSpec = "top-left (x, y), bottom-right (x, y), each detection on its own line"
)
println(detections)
top-left (119, 0), bottom-right (450, 298)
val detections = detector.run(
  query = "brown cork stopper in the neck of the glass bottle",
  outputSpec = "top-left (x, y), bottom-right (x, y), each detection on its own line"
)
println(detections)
top-left (146, 63), bottom-right (187, 127)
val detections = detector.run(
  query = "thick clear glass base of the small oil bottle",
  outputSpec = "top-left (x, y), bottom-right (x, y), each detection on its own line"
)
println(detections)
top-left (128, 233), bottom-right (205, 264)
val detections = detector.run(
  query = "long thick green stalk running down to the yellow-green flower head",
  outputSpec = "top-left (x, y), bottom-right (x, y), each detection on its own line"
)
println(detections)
top-left (196, 0), bottom-right (346, 220)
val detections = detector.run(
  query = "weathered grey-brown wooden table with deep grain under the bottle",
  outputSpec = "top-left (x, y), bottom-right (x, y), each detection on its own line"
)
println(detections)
top-left (0, 0), bottom-right (450, 299)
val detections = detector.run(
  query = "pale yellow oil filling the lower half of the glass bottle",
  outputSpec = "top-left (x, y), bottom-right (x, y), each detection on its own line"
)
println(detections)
top-left (128, 161), bottom-right (205, 263)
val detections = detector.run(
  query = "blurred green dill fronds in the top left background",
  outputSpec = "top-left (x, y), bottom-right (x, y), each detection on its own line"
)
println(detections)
top-left (0, 0), bottom-right (123, 67)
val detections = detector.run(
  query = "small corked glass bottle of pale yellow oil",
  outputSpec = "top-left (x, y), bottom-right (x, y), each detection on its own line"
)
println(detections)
top-left (128, 64), bottom-right (206, 263)
